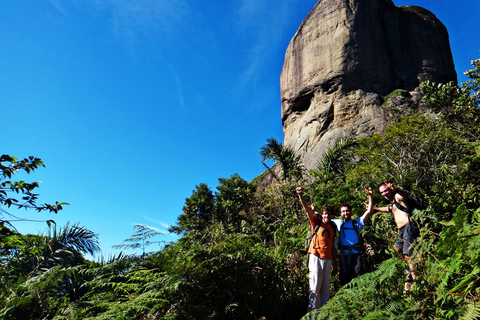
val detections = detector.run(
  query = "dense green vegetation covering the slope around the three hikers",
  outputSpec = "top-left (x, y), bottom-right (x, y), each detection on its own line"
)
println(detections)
top-left (0, 60), bottom-right (480, 320)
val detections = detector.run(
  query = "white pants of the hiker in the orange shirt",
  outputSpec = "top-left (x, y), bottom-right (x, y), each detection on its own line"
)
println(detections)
top-left (308, 254), bottom-right (332, 311)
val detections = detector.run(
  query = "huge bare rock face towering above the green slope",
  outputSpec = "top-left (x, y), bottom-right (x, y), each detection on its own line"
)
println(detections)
top-left (280, 0), bottom-right (457, 169)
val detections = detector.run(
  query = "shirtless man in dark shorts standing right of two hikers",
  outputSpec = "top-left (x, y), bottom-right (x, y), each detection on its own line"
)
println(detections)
top-left (373, 180), bottom-right (418, 291)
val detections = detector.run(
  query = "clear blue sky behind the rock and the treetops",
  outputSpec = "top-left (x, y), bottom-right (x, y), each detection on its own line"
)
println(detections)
top-left (0, 0), bottom-right (480, 255)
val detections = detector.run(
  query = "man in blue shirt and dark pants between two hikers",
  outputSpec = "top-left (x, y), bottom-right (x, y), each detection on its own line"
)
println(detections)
top-left (335, 186), bottom-right (373, 286)
